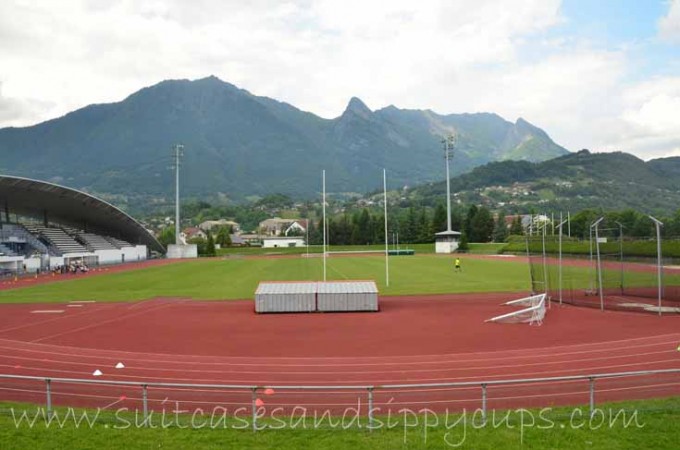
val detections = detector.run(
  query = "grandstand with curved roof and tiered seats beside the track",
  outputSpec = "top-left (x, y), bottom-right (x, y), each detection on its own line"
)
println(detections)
top-left (0, 175), bottom-right (164, 276)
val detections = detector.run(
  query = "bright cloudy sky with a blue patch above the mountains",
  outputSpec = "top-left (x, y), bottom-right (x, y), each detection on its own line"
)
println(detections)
top-left (0, 0), bottom-right (680, 159)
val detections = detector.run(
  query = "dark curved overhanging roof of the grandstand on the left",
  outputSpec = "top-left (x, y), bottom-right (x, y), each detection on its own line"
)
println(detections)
top-left (0, 175), bottom-right (165, 252)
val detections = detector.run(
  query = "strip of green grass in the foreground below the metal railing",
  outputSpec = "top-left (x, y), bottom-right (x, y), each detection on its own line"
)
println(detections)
top-left (0, 397), bottom-right (680, 450)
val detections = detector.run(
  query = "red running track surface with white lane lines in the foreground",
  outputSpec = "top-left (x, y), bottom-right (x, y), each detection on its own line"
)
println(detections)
top-left (0, 293), bottom-right (680, 414)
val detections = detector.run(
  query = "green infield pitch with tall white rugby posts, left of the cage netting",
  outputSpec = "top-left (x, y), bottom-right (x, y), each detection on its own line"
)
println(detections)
top-left (0, 255), bottom-right (530, 303)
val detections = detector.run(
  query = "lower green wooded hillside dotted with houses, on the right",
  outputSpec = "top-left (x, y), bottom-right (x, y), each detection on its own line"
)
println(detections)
top-left (410, 150), bottom-right (680, 213)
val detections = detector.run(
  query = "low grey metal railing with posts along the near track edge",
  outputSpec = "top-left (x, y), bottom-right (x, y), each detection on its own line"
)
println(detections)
top-left (0, 369), bottom-right (680, 431)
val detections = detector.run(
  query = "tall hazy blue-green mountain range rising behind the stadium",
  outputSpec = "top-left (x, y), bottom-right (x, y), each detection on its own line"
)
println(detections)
top-left (0, 77), bottom-right (568, 204)
